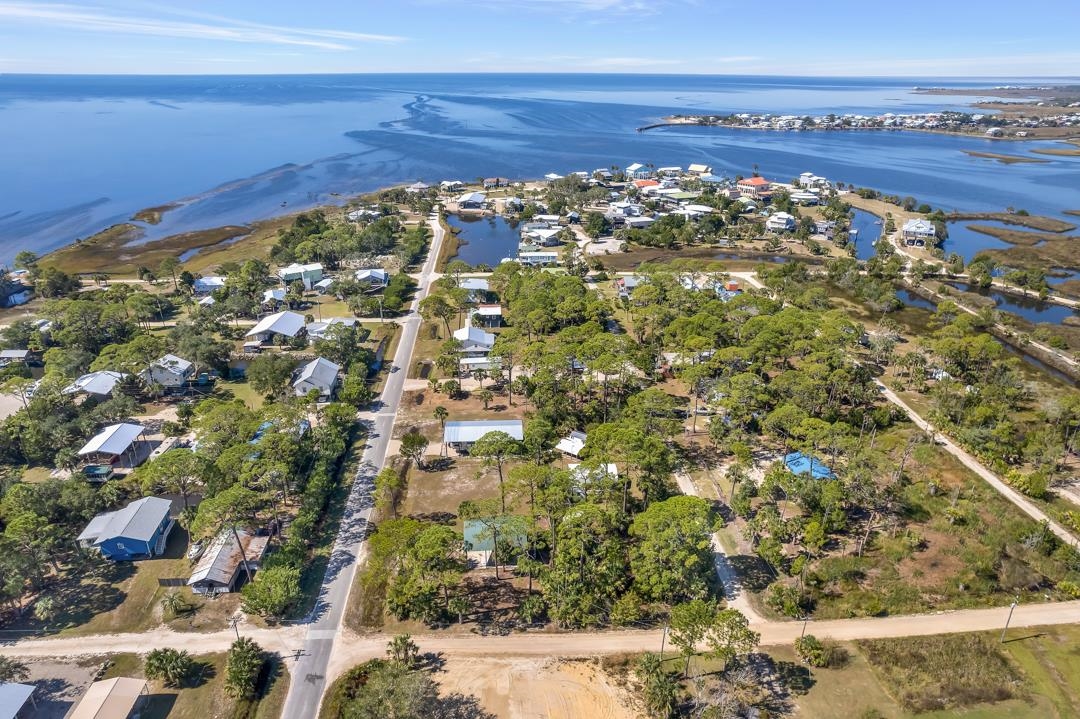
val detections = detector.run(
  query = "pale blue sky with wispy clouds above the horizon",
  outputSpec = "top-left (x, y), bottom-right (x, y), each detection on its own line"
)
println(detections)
top-left (0, 0), bottom-right (1080, 78)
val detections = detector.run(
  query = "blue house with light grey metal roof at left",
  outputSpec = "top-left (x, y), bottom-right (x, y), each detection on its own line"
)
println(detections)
top-left (77, 497), bottom-right (176, 561)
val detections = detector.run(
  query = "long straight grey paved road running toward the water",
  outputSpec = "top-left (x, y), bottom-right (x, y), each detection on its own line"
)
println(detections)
top-left (278, 211), bottom-right (443, 719)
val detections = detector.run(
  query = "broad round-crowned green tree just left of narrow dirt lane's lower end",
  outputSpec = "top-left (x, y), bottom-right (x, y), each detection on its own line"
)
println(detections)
top-left (630, 496), bottom-right (720, 602)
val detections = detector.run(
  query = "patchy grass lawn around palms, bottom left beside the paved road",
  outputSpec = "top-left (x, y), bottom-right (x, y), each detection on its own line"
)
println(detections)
top-left (103, 652), bottom-right (288, 719)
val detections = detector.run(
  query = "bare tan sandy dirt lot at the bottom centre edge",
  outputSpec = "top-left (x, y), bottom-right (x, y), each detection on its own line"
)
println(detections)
top-left (437, 657), bottom-right (642, 719)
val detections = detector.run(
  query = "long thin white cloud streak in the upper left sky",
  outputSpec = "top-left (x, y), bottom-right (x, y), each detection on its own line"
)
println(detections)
top-left (0, 2), bottom-right (404, 50)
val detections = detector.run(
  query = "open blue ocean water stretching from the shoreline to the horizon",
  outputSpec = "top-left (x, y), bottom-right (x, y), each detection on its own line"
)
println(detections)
top-left (0, 74), bottom-right (1080, 263)
